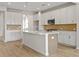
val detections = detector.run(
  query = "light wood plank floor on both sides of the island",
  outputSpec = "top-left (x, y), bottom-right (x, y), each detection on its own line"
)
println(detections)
top-left (0, 41), bottom-right (79, 57)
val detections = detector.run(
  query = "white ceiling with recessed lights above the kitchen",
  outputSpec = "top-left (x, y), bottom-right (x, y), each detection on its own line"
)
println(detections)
top-left (0, 2), bottom-right (66, 12)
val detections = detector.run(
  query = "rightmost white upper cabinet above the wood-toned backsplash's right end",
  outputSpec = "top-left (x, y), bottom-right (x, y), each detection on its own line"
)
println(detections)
top-left (66, 5), bottom-right (76, 23)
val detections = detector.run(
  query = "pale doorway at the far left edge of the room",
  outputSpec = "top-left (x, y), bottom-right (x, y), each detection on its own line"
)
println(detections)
top-left (0, 11), bottom-right (5, 41)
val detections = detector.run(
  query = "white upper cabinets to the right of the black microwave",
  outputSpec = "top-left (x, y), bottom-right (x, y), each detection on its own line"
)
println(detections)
top-left (55, 5), bottom-right (76, 24)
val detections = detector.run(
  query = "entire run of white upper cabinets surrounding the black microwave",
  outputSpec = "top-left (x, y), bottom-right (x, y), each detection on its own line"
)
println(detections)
top-left (34, 5), bottom-right (76, 24)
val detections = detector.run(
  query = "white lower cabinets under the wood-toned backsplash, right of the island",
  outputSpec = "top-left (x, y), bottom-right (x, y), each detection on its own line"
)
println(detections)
top-left (58, 31), bottom-right (76, 46)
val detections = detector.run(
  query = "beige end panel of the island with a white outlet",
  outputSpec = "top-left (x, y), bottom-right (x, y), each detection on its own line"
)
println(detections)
top-left (48, 34), bottom-right (58, 56)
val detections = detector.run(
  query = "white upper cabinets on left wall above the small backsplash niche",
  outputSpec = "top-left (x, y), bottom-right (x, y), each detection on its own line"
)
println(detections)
top-left (6, 12), bottom-right (23, 24)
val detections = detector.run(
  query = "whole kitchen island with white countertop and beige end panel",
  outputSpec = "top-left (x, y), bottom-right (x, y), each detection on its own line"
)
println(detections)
top-left (23, 31), bottom-right (58, 56)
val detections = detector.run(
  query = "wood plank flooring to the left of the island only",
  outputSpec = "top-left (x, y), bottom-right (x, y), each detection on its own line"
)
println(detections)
top-left (0, 41), bottom-right (42, 57)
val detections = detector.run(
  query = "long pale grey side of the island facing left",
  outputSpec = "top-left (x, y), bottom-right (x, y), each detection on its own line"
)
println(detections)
top-left (23, 33), bottom-right (45, 55)
